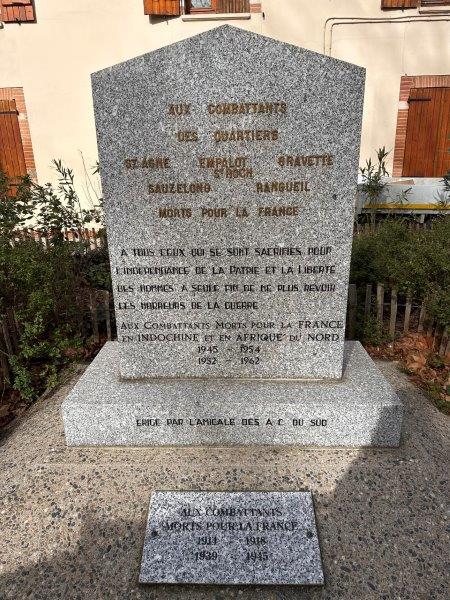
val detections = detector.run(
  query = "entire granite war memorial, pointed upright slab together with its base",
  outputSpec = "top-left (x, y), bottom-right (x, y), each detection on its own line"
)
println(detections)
top-left (62, 26), bottom-right (402, 446)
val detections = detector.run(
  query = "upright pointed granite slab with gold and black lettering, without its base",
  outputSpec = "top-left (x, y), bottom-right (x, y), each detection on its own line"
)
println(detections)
top-left (93, 26), bottom-right (364, 379)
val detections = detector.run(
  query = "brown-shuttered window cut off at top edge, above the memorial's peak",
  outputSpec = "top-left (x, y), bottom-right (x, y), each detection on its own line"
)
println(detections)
top-left (144, 0), bottom-right (261, 17)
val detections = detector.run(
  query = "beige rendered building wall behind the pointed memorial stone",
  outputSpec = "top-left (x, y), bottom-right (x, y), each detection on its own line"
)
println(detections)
top-left (0, 0), bottom-right (450, 197)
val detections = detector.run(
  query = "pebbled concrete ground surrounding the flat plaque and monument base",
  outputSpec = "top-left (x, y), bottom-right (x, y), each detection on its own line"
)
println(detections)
top-left (0, 363), bottom-right (449, 600)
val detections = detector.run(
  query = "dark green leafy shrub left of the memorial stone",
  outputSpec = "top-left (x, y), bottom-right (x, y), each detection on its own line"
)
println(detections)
top-left (0, 161), bottom-right (110, 401)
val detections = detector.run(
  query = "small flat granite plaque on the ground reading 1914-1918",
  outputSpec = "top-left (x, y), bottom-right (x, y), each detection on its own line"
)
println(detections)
top-left (139, 492), bottom-right (323, 585)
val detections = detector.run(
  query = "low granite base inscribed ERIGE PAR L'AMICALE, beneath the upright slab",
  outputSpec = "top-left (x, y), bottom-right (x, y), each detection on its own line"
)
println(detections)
top-left (62, 342), bottom-right (403, 446)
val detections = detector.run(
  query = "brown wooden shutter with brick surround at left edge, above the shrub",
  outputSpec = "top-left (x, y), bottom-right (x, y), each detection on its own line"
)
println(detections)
top-left (0, 88), bottom-right (36, 188)
